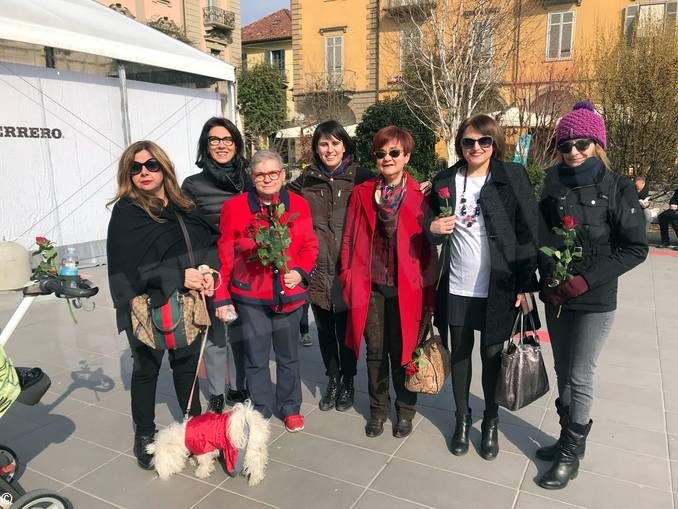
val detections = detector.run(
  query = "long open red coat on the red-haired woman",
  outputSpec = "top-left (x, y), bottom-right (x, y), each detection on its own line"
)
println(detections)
top-left (339, 173), bottom-right (436, 365)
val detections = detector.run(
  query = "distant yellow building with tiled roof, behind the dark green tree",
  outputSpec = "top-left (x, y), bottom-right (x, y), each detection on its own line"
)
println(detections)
top-left (242, 9), bottom-right (294, 120)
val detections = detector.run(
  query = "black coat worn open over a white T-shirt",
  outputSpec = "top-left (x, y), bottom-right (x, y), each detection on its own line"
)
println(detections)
top-left (426, 158), bottom-right (538, 346)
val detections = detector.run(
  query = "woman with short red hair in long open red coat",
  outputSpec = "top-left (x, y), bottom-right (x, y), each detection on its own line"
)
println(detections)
top-left (339, 126), bottom-right (435, 438)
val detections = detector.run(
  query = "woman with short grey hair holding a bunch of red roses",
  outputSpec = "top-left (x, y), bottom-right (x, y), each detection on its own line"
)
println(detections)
top-left (214, 151), bottom-right (318, 432)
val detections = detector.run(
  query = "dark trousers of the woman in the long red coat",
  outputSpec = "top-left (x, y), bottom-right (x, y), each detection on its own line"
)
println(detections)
top-left (365, 287), bottom-right (417, 419)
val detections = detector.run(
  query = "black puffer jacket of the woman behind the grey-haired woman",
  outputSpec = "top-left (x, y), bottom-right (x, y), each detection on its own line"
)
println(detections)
top-left (181, 161), bottom-right (253, 229)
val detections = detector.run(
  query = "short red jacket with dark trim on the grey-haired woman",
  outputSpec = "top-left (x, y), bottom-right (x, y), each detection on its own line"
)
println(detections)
top-left (214, 189), bottom-right (318, 313)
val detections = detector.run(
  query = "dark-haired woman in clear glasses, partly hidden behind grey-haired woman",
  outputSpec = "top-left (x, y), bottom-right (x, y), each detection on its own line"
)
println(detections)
top-left (181, 117), bottom-right (252, 413)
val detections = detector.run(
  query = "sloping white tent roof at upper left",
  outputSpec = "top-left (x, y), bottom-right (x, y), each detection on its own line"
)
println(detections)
top-left (0, 0), bottom-right (235, 82)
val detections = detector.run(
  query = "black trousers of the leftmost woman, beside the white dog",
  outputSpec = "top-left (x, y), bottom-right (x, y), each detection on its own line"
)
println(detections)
top-left (126, 330), bottom-right (202, 435)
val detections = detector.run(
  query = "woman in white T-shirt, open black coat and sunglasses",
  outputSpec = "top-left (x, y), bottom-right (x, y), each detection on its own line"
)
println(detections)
top-left (427, 115), bottom-right (537, 460)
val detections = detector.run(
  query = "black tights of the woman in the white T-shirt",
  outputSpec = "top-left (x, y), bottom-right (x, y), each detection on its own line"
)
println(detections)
top-left (450, 326), bottom-right (503, 417)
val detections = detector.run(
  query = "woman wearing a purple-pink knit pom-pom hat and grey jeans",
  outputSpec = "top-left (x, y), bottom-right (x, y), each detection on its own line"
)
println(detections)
top-left (537, 101), bottom-right (648, 489)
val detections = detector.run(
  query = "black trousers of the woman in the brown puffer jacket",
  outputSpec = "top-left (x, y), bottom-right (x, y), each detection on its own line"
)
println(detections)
top-left (311, 304), bottom-right (357, 378)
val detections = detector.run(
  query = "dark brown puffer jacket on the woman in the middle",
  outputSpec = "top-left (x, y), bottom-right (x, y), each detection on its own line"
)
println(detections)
top-left (287, 163), bottom-right (374, 310)
